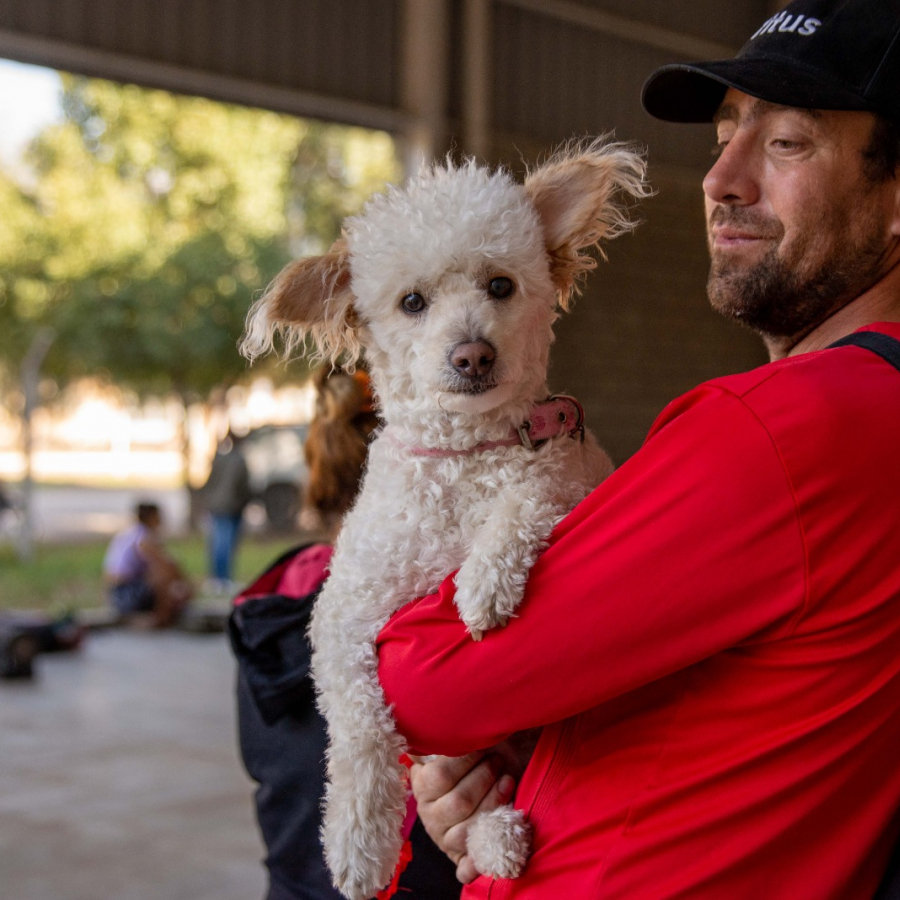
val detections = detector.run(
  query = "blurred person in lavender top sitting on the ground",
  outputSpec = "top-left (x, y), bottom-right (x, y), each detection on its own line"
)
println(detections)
top-left (103, 503), bottom-right (194, 628)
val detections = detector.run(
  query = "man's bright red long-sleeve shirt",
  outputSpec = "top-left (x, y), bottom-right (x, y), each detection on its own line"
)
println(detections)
top-left (379, 324), bottom-right (900, 900)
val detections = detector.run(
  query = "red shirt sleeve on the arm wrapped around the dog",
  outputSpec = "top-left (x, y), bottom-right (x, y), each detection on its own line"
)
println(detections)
top-left (378, 385), bottom-right (806, 756)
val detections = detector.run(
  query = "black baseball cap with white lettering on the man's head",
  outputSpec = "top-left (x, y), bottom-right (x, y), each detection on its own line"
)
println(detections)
top-left (641, 0), bottom-right (900, 122)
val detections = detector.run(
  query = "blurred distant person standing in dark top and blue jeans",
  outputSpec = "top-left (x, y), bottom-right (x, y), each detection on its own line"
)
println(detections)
top-left (201, 429), bottom-right (250, 593)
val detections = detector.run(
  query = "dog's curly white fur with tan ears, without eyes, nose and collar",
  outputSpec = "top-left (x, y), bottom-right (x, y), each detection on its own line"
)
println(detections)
top-left (243, 140), bottom-right (647, 900)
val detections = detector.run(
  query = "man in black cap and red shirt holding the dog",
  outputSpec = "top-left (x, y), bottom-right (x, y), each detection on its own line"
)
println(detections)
top-left (380, 0), bottom-right (900, 900)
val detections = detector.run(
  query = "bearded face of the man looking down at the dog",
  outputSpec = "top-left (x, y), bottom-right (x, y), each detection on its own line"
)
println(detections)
top-left (703, 89), bottom-right (896, 349)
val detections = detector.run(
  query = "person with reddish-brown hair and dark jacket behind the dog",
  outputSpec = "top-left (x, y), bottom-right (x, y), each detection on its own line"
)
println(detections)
top-left (229, 369), bottom-right (461, 900)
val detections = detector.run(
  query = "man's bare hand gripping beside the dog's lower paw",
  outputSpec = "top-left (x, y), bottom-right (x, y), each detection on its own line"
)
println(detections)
top-left (410, 750), bottom-right (516, 884)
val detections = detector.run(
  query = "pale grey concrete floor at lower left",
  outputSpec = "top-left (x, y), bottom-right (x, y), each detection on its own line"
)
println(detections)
top-left (0, 631), bottom-right (265, 900)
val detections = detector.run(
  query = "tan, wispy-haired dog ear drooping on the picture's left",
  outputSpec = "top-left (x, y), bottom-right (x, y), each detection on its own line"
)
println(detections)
top-left (240, 238), bottom-right (362, 368)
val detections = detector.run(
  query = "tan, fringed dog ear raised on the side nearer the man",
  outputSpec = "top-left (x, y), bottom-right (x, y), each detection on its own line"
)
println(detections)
top-left (525, 138), bottom-right (650, 309)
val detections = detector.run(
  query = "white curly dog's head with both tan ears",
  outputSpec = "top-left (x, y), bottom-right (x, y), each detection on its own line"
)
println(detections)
top-left (242, 141), bottom-right (647, 421)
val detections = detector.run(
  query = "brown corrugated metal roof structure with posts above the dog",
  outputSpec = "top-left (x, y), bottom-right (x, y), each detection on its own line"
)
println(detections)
top-left (0, 0), bottom-right (769, 162)
